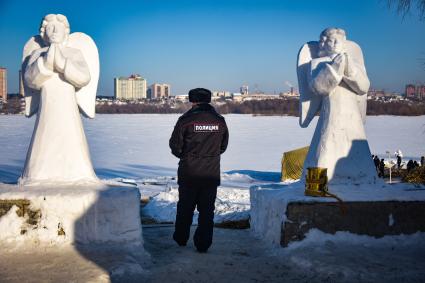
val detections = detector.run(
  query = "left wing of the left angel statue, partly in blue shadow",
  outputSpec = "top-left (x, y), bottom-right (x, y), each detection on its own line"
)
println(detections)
top-left (21, 35), bottom-right (45, 117)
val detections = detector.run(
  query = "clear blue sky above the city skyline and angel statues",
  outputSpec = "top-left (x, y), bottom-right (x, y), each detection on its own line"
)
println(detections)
top-left (0, 0), bottom-right (425, 95)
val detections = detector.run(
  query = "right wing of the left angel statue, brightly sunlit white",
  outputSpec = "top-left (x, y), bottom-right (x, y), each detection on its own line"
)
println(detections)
top-left (68, 32), bottom-right (99, 118)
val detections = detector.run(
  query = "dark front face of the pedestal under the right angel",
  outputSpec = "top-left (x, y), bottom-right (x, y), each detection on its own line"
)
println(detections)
top-left (280, 201), bottom-right (425, 247)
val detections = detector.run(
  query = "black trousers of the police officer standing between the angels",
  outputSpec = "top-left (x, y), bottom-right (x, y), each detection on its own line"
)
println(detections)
top-left (173, 184), bottom-right (217, 251)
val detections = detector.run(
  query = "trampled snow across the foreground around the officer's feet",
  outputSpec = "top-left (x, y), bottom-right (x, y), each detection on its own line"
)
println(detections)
top-left (0, 227), bottom-right (425, 283)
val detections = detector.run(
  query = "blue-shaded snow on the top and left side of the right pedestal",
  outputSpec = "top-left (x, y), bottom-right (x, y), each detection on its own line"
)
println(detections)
top-left (250, 182), bottom-right (425, 245)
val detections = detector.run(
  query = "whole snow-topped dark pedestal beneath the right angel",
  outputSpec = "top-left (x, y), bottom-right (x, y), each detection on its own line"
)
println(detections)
top-left (250, 182), bottom-right (425, 247)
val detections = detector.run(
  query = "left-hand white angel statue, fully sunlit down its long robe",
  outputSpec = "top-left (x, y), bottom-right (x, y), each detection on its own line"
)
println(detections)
top-left (19, 14), bottom-right (99, 185)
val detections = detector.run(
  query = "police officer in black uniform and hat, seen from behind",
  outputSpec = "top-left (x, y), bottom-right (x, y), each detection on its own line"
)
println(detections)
top-left (170, 88), bottom-right (229, 253)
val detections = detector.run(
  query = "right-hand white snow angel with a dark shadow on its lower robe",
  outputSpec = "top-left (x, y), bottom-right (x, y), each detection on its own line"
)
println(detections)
top-left (297, 28), bottom-right (376, 184)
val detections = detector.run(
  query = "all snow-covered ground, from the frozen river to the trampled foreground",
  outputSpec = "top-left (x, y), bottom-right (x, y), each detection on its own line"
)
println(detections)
top-left (0, 115), bottom-right (425, 282)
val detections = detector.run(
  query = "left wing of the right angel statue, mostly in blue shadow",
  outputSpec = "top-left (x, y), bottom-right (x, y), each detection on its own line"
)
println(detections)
top-left (297, 41), bottom-right (322, 128)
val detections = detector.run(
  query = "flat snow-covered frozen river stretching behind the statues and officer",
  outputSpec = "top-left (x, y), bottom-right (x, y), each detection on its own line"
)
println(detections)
top-left (0, 114), bottom-right (425, 182)
